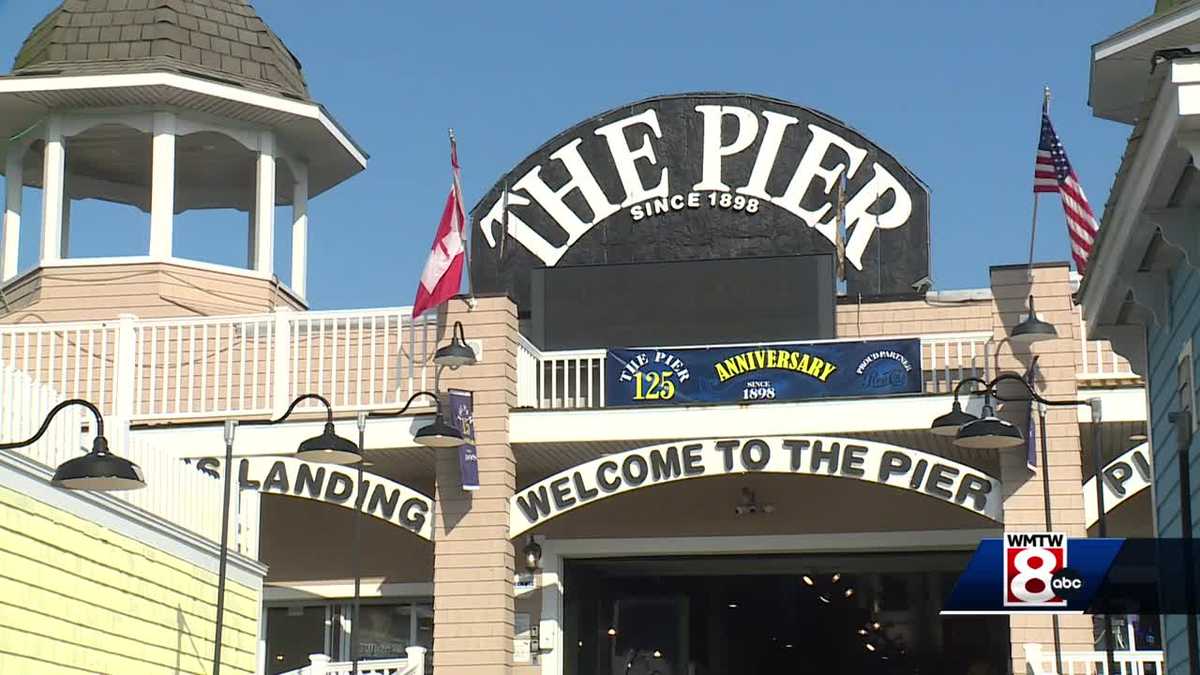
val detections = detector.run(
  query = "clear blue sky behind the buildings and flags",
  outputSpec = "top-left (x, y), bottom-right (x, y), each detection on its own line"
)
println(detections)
top-left (0, 0), bottom-right (1153, 309)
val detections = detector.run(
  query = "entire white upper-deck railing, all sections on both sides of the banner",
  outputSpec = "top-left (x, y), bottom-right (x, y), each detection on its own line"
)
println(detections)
top-left (0, 307), bottom-right (1139, 422)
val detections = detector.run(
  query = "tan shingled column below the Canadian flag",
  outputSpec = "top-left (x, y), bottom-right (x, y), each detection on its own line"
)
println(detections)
top-left (433, 298), bottom-right (517, 675)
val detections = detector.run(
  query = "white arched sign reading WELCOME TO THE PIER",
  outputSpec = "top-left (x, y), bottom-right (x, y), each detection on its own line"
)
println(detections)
top-left (509, 436), bottom-right (1003, 537)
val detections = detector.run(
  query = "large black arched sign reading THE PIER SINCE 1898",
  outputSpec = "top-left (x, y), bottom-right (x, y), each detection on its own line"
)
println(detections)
top-left (470, 94), bottom-right (929, 307)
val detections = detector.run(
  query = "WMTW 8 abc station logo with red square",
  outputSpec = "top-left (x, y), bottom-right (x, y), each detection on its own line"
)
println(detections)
top-left (1003, 532), bottom-right (1084, 608)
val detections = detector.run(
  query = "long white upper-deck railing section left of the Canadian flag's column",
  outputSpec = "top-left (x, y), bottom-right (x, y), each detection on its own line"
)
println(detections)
top-left (0, 307), bottom-right (436, 420)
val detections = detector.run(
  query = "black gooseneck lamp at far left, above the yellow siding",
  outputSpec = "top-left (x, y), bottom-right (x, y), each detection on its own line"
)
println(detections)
top-left (0, 399), bottom-right (146, 492)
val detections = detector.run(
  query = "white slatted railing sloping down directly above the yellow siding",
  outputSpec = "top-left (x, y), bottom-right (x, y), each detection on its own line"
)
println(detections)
top-left (0, 364), bottom-right (259, 542)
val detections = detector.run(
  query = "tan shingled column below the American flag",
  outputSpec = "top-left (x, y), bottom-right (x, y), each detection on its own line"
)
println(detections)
top-left (991, 263), bottom-right (1093, 673)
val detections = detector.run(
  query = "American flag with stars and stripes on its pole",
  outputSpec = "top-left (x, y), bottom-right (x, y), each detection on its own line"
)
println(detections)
top-left (1033, 110), bottom-right (1099, 274)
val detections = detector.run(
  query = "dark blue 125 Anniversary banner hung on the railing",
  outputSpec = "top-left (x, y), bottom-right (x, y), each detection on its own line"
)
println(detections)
top-left (605, 339), bottom-right (923, 406)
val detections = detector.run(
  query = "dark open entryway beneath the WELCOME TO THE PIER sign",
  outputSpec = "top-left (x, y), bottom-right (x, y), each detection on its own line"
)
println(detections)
top-left (564, 554), bottom-right (1009, 675)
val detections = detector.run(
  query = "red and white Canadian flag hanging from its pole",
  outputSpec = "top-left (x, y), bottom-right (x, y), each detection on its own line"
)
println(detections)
top-left (413, 131), bottom-right (467, 318)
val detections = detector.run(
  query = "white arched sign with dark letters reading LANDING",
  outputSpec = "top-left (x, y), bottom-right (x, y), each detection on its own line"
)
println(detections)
top-left (196, 456), bottom-right (433, 539)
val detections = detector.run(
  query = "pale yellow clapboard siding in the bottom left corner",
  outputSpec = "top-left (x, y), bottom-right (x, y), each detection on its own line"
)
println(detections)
top-left (0, 488), bottom-right (259, 675)
